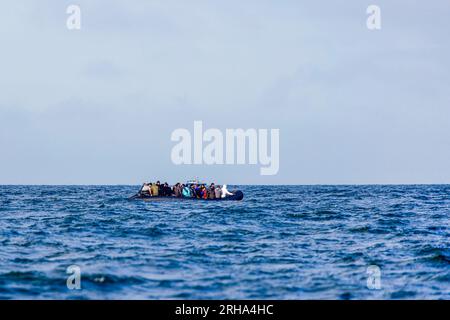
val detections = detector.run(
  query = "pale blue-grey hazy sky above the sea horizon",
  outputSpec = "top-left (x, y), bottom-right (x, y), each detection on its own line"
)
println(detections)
top-left (0, 0), bottom-right (450, 185)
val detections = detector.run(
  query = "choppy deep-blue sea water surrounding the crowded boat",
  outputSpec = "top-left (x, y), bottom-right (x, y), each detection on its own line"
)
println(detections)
top-left (0, 185), bottom-right (450, 299)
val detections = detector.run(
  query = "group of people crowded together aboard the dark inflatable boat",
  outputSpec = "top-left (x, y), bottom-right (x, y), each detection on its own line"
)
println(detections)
top-left (140, 181), bottom-right (233, 199)
